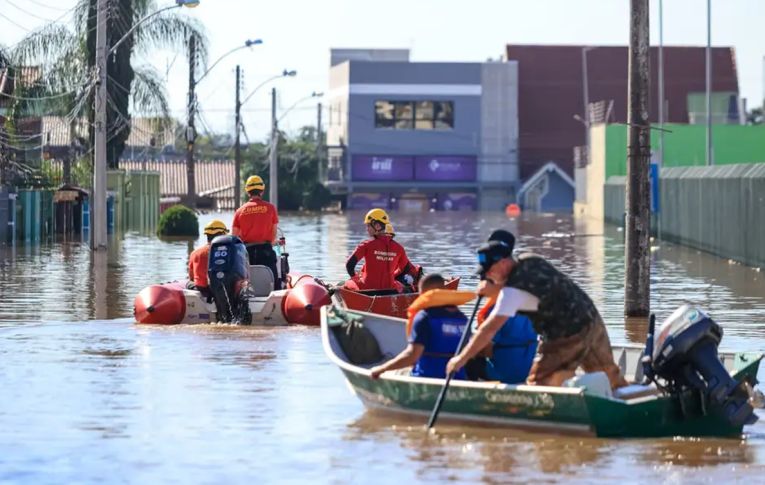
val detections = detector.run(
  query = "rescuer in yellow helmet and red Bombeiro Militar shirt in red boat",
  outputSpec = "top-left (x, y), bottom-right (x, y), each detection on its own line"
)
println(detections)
top-left (344, 209), bottom-right (418, 292)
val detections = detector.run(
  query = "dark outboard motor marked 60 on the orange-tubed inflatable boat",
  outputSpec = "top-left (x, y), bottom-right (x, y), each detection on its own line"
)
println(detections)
top-left (207, 235), bottom-right (250, 324)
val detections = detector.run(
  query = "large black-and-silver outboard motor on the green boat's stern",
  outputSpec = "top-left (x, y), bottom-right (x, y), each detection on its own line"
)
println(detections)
top-left (644, 305), bottom-right (757, 426)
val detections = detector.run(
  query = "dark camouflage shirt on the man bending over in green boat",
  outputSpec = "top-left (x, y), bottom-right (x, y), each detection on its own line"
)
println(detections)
top-left (505, 253), bottom-right (599, 340)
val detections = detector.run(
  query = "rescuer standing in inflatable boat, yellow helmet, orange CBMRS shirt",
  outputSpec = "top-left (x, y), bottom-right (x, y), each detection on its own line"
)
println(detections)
top-left (231, 175), bottom-right (281, 290)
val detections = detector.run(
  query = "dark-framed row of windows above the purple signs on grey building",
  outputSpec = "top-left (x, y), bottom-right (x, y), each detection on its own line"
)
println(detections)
top-left (375, 101), bottom-right (454, 130)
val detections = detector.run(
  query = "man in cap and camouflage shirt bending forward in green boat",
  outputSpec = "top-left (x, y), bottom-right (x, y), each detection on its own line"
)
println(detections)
top-left (447, 230), bottom-right (627, 389)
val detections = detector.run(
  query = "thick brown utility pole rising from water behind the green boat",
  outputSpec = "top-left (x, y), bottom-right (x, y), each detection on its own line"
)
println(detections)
top-left (624, 0), bottom-right (651, 317)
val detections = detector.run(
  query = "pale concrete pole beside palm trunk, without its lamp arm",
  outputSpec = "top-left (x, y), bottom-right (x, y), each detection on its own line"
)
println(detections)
top-left (90, 0), bottom-right (108, 250)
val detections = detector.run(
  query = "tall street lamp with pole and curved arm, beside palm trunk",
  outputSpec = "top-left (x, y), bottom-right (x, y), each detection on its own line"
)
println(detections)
top-left (90, 0), bottom-right (199, 250)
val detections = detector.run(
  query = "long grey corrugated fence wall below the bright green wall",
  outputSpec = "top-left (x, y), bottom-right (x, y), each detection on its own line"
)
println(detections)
top-left (605, 164), bottom-right (765, 267)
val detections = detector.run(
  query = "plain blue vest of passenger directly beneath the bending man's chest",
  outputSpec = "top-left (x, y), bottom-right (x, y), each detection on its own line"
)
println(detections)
top-left (486, 315), bottom-right (537, 384)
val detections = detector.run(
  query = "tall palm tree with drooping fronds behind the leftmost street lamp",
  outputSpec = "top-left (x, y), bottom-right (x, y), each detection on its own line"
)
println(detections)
top-left (12, 0), bottom-right (207, 167)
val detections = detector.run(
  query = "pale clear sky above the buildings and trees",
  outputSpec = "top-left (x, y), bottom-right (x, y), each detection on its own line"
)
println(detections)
top-left (0, 0), bottom-right (765, 139)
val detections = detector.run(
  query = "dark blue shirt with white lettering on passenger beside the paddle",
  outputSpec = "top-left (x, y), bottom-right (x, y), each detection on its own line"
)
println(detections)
top-left (412, 307), bottom-right (467, 379)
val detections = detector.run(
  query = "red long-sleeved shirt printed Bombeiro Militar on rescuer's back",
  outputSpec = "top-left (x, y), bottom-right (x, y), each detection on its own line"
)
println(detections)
top-left (352, 235), bottom-right (409, 290)
